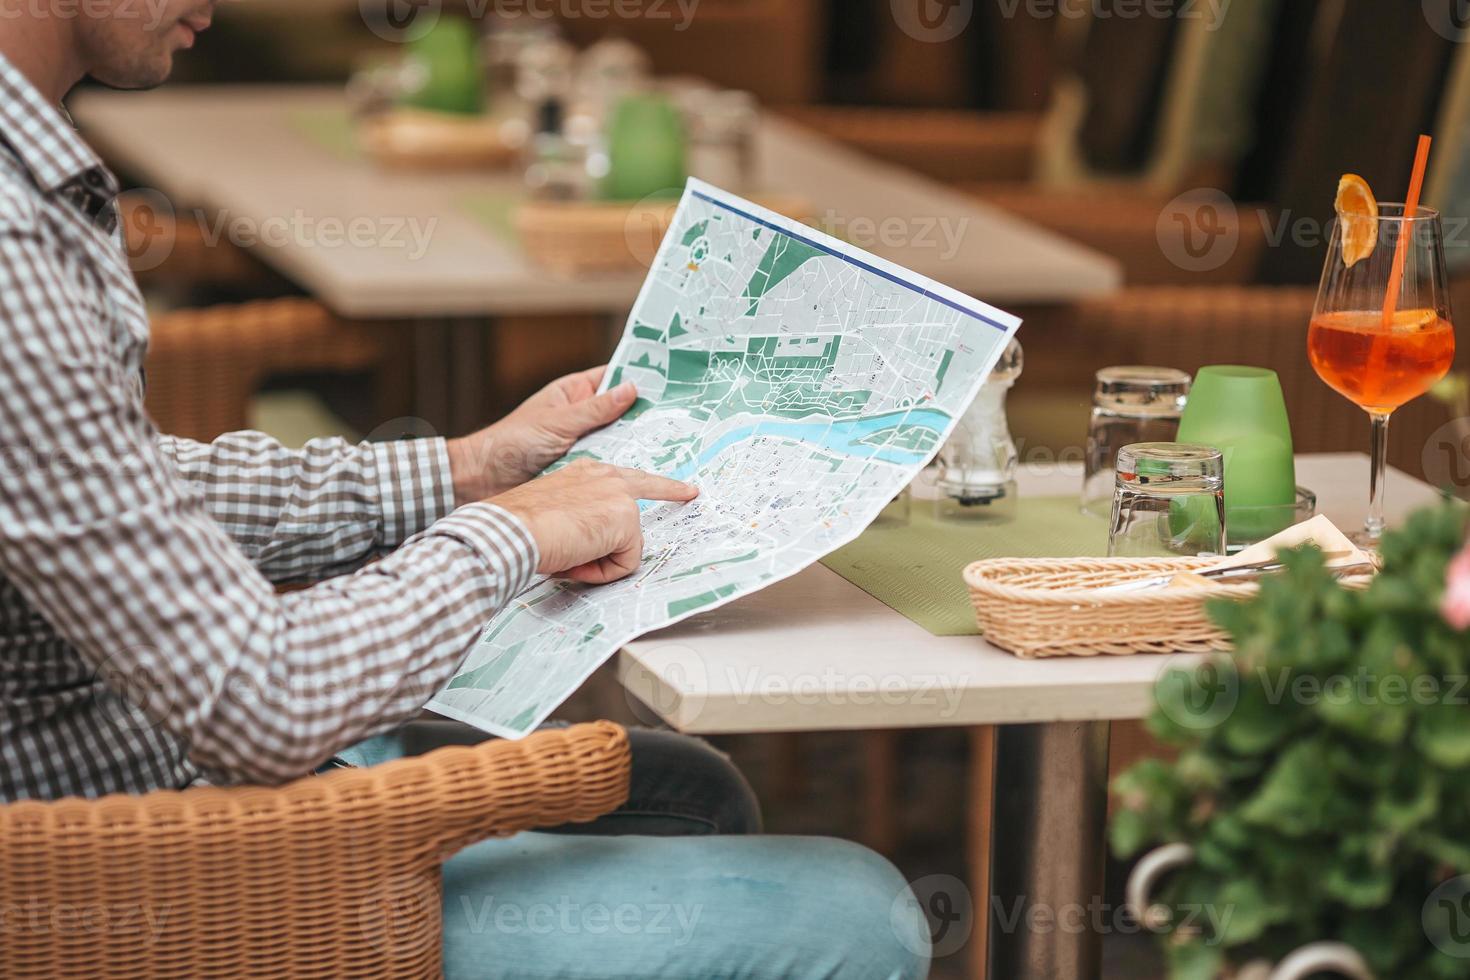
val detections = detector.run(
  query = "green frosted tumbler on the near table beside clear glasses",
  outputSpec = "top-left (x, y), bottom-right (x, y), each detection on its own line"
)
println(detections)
top-left (1179, 364), bottom-right (1297, 545)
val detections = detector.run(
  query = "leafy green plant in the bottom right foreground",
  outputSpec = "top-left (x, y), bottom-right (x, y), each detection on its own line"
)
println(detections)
top-left (1110, 504), bottom-right (1470, 980)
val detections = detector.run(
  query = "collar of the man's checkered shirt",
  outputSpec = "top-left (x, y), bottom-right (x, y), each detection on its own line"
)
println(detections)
top-left (0, 54), bottom-right (116, 192)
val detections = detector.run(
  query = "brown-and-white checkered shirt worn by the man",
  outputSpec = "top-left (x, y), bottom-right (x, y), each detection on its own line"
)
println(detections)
top-left (0, 57), bottom-right (538, 801)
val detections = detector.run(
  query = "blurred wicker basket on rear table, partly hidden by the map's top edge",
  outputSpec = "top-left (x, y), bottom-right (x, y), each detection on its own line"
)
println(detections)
top-left (516, 194), bottom-right (811, 278)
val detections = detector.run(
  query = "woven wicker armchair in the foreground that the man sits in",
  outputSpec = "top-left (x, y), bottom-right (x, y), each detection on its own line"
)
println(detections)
top-left (0, 721), bottom-right (629, 980)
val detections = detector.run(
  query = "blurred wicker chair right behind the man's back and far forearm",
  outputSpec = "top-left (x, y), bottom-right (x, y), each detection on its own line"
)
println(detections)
top-left (147, 298), bottom-right (392, 441)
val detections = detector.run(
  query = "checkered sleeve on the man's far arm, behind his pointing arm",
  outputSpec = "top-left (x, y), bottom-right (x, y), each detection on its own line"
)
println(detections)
top-left (157, 432), bottom-right (454, 582)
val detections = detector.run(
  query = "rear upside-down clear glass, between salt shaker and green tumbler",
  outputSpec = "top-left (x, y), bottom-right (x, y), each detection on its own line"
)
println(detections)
top-left (1082, 366), bottom-right (1191, 517)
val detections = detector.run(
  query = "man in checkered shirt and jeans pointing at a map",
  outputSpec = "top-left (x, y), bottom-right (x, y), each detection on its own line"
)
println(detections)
top-left (0, 0), bottom-right (929, 980)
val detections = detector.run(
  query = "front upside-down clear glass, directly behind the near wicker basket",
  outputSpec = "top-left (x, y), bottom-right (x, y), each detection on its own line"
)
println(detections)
top-left (1107, 442), bottom-right (1226, 558)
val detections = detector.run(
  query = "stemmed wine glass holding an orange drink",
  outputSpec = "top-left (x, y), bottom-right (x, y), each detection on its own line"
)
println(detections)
top-left (1307, 203), bottom-right (1455, 548)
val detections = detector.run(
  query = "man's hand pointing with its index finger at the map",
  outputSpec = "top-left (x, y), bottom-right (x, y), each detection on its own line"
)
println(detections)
top-left (490, 460), bottom-right (700, 585)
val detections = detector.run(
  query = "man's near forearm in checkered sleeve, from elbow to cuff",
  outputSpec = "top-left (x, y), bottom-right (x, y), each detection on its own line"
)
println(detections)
top-left (183, 504), bottom-right (538, 783)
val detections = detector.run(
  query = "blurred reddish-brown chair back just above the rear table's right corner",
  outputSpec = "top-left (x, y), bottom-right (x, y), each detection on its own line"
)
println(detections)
top-left (963, 182), bottom-right (1270, 287)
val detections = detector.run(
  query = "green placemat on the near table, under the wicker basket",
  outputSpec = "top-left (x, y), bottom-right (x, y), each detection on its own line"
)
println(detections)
top-left (822, 497), bottom-right (1107, 636)
